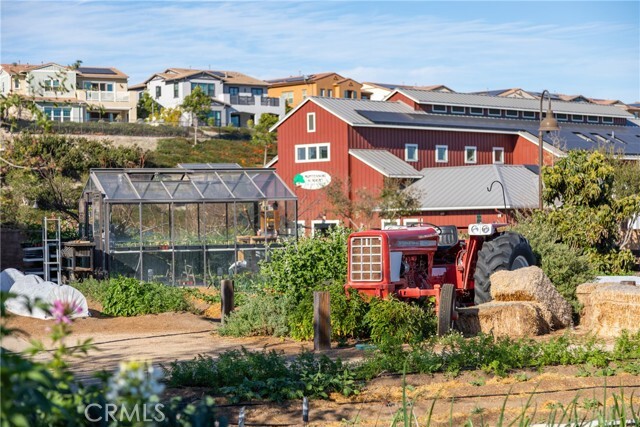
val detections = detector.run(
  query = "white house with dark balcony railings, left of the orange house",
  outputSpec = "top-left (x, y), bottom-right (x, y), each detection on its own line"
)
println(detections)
top-left (132, 68), bottom-right (284, 127)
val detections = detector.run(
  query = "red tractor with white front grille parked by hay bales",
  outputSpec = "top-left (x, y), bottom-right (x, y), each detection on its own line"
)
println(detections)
top-left (345, 223), bottom-right (536, 335)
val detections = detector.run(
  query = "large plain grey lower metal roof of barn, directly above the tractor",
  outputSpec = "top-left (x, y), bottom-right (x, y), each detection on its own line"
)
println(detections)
top-left (407, 165), bottom-right (538, 211)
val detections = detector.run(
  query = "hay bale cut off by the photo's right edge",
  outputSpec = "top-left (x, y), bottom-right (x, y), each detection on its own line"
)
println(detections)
top-left (578, 283), bottom-right (640, 337)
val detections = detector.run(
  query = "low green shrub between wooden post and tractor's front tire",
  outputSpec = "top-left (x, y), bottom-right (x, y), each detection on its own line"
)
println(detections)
top-left (364, 297), bottom-right (435, 343)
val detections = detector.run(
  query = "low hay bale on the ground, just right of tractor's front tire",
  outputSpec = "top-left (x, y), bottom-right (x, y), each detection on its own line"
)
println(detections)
top-left (455, 301), bottom-right (552, 338)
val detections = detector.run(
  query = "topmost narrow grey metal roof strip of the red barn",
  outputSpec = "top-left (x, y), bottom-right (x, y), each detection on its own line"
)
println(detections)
top-left (389, 89), bottom-right (632, 118)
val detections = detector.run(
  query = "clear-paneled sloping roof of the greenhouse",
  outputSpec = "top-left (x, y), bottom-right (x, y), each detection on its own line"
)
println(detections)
top-left (84, 168), bottom-right (296, 203)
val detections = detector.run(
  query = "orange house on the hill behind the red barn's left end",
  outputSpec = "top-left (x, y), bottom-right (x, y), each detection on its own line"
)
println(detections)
top-left (267, 72), bottom-right (363, 107)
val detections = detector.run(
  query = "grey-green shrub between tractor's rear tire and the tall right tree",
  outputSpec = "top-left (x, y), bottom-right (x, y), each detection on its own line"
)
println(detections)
top-left (513, 217), bottom-right (595, 311)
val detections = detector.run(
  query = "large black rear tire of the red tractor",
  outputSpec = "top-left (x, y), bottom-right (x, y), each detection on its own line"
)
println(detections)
top-left (473, 231), bottom-right (536, 305)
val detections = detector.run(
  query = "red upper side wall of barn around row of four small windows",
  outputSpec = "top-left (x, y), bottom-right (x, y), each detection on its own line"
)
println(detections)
top-left (348, 127), bottom-right (517, 170)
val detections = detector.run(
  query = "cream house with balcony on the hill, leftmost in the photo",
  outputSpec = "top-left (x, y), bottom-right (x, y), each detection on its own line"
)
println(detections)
top-left (0, 63), bottom-right (136, 122)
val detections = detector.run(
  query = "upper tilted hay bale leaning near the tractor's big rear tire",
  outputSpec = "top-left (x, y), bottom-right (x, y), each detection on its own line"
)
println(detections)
top-left (491, 266), bottom-right (572, 329)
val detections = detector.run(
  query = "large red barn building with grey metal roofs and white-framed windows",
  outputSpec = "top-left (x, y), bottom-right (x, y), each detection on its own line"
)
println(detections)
top-left (270, 89), bottom-right (640, 229)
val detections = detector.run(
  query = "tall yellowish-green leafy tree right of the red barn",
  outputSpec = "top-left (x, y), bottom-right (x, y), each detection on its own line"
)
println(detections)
top-left (537, 150), bottom-right (640, 273)
